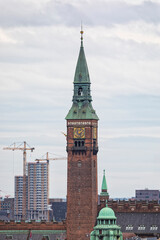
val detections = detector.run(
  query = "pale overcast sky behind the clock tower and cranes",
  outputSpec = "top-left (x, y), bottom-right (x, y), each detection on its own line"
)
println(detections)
top-left (0, 0), bottom-right (160, 197)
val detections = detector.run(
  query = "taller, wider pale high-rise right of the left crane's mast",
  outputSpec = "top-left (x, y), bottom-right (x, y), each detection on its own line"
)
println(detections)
top-left (28, 162), bottom-right (49, 220)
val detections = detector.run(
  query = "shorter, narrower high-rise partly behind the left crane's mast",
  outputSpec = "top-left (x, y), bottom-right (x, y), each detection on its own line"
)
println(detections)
top-left (14, 176), bottom-right (28, 221)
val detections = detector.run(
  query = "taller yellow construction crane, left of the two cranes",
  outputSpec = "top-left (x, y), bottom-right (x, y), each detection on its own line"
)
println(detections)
top-left (3, 141), bottom-right (35, 220)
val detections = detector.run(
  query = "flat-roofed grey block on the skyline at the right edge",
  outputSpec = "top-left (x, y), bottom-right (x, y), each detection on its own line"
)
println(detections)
top-left (136, 188), bottom-right (160, 203)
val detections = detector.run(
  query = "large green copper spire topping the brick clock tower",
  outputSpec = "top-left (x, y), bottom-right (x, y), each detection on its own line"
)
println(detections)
top-left (66, 29), bottom-right (98, 120)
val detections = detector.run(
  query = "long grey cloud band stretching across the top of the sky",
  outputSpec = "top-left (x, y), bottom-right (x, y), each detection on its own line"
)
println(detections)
top-left (0, 0), bottom-right (160, 27)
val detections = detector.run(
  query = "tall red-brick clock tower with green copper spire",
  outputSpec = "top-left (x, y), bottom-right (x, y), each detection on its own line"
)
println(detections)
top-left (66, 31), bottom-right (98, 240)
